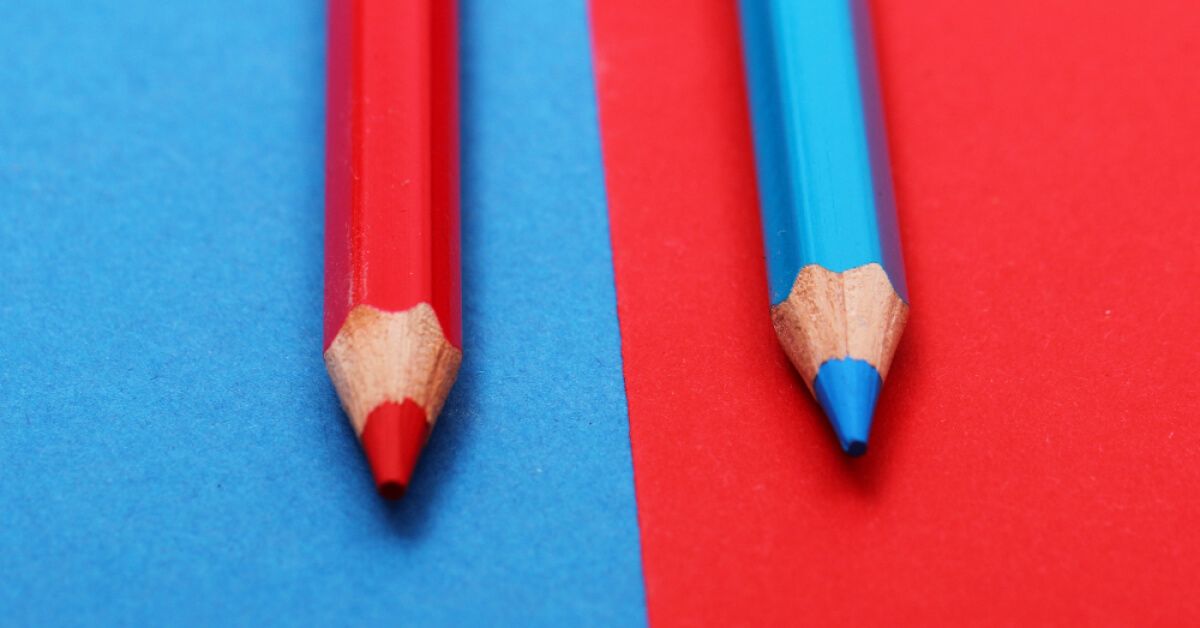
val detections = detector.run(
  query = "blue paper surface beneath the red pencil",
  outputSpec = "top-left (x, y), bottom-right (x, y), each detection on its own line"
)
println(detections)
top-left (0, 0), bottom-right (644, 626)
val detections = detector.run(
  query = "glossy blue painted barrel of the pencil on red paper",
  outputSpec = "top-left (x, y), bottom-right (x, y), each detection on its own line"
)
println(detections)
top-left (740, 0), bottom-right (908, 305)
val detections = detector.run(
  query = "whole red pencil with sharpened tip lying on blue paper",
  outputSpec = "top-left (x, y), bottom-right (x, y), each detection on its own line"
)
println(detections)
top-left (324, 0), bottom-right (462, 498)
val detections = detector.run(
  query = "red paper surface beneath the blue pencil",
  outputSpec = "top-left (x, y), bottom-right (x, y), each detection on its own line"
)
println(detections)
top-left (593, 0), bottom-right (1200, 626)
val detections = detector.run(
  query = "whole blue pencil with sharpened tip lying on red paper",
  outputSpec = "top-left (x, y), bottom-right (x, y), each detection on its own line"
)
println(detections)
top-left (740, 0), bottom-right (908, 455)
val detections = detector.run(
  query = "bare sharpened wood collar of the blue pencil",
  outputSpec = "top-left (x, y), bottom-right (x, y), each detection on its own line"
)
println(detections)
top-left (772, 263), bottom-right (908, 389)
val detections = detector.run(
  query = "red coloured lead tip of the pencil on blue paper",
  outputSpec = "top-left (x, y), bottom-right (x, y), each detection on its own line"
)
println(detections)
top-left (362, 400), bottom-right (430, 500)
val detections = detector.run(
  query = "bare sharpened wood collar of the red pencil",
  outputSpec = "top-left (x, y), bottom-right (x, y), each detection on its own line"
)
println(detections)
top-left (325, 303), bottom-right (462, 435)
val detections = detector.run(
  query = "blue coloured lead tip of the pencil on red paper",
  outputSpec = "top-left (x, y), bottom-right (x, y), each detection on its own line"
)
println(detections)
top-left (812, 358), bottom-right (883, 456)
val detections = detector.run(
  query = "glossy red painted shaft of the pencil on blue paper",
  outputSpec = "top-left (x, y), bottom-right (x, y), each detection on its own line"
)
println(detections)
top-left (325, 0), bottom-right (461, 348)
